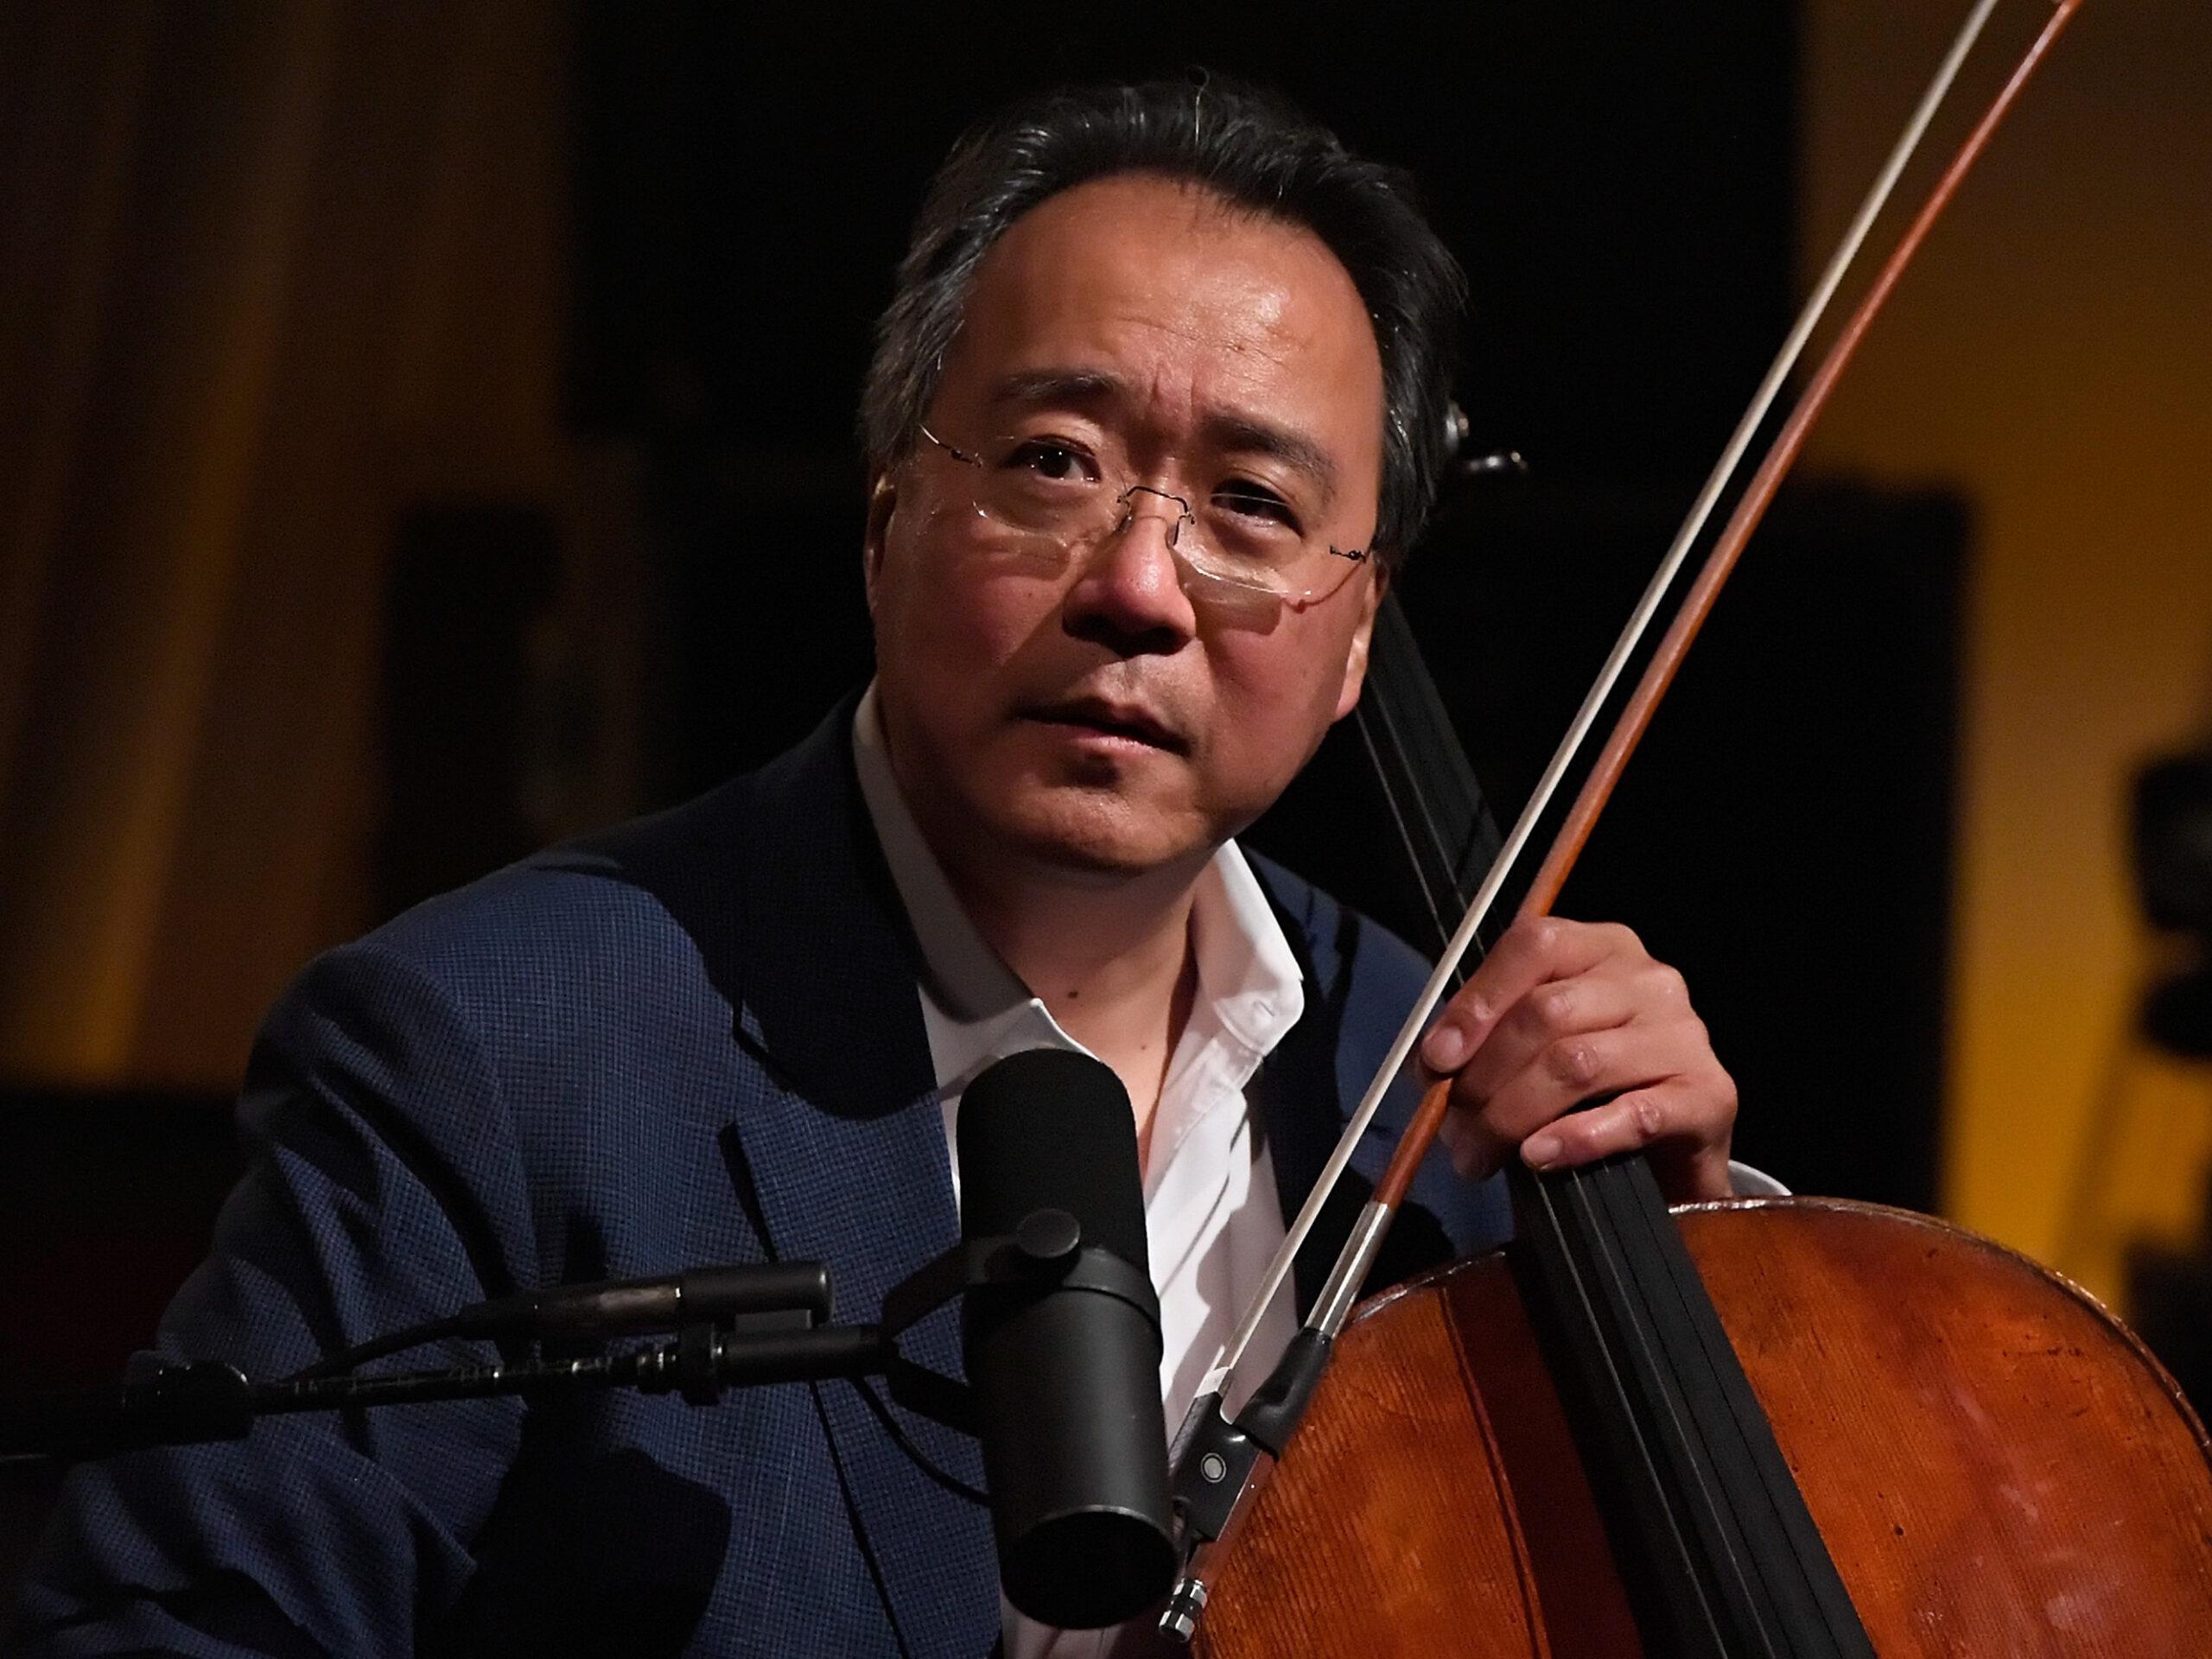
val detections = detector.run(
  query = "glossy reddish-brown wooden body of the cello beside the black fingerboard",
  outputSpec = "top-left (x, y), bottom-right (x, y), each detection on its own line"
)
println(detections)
top-left (1199, 1199), bottom-right (2212, 1659)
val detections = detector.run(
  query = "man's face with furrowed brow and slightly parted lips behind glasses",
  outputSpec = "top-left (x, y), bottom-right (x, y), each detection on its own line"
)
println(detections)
top-left (868, 175), bottom-right (1382, 876)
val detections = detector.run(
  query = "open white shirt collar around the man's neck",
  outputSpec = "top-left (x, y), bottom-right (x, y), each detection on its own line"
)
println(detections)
top-left (852, 683), bottom-right (1305, 1090)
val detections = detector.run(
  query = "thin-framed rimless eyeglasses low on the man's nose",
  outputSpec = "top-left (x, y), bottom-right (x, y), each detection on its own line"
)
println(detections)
top-left (920, 427), bottom-right (1371, 611)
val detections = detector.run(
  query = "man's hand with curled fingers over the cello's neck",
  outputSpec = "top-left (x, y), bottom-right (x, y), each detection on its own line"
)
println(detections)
top-left (1421, 916), bottom-right (1737, 1204)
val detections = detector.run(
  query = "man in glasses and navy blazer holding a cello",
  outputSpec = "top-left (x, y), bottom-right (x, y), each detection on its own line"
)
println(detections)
top-left (13, 86), bottom-right (1734, 1655)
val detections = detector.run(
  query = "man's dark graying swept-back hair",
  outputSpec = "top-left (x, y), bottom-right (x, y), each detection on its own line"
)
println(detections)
top-left (861, 79), bottom-right (1466, 564)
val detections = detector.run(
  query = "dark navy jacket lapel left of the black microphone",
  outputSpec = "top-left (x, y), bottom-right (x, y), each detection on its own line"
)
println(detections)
top-left (730, 702), bottom-right (998, 1655)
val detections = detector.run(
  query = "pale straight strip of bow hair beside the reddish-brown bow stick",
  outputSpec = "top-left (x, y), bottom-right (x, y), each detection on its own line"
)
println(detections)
top-left (1210, 0), bottom-right (1998, 1387)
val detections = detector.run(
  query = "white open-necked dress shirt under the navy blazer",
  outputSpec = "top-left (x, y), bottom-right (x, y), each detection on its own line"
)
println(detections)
top-left (852, 686), bottom-right (1783, 1659)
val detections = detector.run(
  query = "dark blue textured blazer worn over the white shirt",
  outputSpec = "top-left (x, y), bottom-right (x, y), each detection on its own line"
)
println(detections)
top-left (16, 703), bottom-right (1506, 1659)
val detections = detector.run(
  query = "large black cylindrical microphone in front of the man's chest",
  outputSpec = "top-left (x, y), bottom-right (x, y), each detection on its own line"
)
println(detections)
top-left (957, 1048), bottom-right (1174, 1630)
